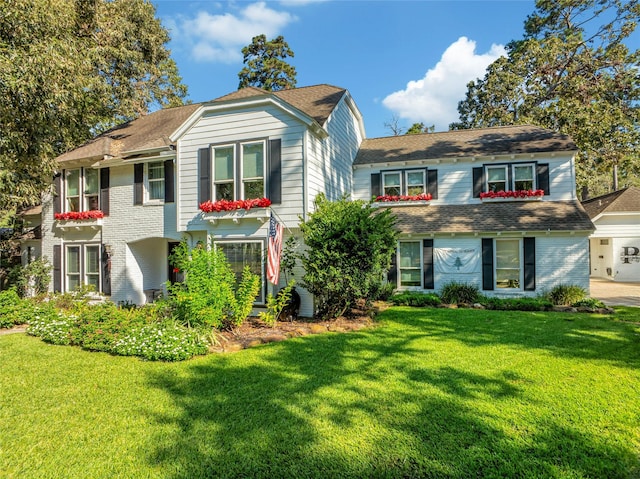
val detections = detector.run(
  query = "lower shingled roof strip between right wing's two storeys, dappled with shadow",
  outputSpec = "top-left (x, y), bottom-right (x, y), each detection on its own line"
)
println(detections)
top-left (390, 201), bottom-right (595, 234)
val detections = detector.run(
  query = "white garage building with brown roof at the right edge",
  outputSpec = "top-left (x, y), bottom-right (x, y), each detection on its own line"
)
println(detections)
top-left (582, 187), bottom-right (640, 281)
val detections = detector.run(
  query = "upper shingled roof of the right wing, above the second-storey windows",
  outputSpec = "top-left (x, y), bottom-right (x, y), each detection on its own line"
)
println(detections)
top-left (354, 125), bottom-right (577, 165)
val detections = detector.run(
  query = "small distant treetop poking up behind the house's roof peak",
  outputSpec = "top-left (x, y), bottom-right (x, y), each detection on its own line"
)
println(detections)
top-left (238, 35), bottom-right (296, 91)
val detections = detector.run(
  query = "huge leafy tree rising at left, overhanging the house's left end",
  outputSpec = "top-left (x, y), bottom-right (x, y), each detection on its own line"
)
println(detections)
top-left (0, 0), bottom-right (186, 213)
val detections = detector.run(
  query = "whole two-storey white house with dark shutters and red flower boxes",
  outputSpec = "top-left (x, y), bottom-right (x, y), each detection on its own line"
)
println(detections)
top-left (37, 85), bottom-right (594, 316)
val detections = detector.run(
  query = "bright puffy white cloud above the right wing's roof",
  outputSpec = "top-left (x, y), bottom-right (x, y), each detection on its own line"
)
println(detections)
top-left (382, 37), bottom-right (506, 131)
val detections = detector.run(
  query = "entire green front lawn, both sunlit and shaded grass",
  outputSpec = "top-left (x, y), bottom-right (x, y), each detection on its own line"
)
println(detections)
top-left (0, 308), bottom-right (640, 479)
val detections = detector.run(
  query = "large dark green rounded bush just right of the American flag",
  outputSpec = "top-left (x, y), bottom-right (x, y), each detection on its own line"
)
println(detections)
top-left (300, 195), bottom-right (398, 319)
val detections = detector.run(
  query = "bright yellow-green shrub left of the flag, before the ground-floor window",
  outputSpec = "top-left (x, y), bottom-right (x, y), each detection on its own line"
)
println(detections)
top-left (169, 242), bottom-right (260, 329)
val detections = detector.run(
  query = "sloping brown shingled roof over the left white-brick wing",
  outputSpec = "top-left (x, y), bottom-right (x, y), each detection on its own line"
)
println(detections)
top-left (58, 104), bottom-right (200, 162)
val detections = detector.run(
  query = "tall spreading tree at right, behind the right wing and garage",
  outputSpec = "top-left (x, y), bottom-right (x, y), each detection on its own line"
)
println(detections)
top-left (451, 0), bottom-right (640, 194)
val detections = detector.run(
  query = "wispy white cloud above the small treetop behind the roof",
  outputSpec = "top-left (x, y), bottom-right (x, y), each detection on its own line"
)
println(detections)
top-left (170, 2), bottom-right (297, 63)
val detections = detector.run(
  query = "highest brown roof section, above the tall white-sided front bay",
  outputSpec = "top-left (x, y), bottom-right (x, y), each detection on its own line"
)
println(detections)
top-left (213, 84), bottom-right (347, 125)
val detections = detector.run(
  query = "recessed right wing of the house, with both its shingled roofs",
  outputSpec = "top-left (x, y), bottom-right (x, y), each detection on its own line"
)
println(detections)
top-left (353, 126), bottom-right (593, 296)
